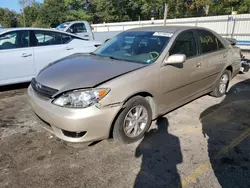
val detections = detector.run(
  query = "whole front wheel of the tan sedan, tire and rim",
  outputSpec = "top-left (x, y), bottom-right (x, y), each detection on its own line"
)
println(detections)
top-left (113, 96), bottom-right (152, 143)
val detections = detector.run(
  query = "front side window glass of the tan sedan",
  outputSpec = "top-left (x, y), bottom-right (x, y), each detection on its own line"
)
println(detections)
top-left (170, 31), bottom-right (197, 58)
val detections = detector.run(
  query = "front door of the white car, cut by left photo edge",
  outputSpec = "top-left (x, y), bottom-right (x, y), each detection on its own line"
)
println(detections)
top-left (0, 30), bottom-right (36, 85)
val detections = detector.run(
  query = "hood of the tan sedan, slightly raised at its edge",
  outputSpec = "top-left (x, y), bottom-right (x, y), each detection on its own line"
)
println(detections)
top-left (36, 54), bottom-right (146, 92)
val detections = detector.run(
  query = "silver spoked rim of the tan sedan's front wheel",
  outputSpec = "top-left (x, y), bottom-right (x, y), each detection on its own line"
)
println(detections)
top-left (123, 105), bottom-right (148, 138)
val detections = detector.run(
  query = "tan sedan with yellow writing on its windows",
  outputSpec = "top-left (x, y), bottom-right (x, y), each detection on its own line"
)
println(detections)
top-left (28, 26), bottom-right (240, 143)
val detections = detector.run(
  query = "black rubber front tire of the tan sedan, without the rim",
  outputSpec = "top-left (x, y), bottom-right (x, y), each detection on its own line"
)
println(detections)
top-left (113, 96), bottom-right (152, 144)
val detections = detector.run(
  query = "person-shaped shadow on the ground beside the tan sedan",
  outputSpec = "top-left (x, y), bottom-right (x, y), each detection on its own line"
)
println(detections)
top-left (134, 117), bottom-right (183, 188)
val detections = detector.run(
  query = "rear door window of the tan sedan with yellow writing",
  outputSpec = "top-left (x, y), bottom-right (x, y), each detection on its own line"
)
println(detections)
top-left (197, 30), bottom-right (218, 54)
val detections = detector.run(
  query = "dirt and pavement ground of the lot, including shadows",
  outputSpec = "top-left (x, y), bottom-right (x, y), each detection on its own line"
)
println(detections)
top-left (0, 74), bottom-right (250, 188)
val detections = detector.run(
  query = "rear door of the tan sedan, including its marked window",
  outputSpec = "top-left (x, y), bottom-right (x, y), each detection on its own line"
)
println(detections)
top-left (197, 30), bottom-right (228, 88)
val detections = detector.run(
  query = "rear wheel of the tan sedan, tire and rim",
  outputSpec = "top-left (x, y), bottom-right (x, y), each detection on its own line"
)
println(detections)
top-left (210, 70), bottom-right (231, 97)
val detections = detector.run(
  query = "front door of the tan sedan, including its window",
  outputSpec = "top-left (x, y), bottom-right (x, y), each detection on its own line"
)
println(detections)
top-left (160, 30), bottom-right (203, 111)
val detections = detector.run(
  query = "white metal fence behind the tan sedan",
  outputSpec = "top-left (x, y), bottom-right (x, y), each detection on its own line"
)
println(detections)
top-left (92, 14), bottom-right (250, 41)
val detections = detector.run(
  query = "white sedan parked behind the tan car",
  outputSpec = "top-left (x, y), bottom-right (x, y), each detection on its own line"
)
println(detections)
top-left (0, 28), bottom-right (101, 86)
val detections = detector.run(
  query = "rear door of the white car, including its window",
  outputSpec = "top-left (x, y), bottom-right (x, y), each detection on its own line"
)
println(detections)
top-left (30, 30), bottom-right (74, 72)
